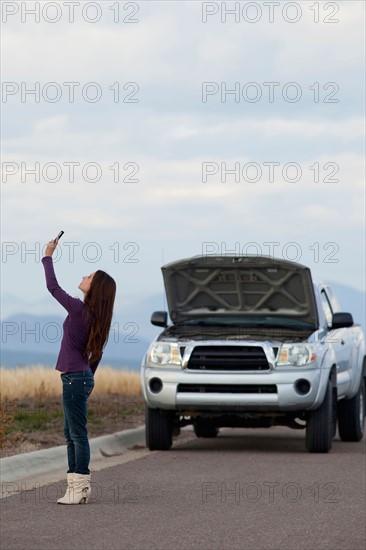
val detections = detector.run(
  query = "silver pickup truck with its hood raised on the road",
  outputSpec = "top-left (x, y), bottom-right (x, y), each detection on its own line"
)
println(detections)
top-left (141, 256), bottom-right (366, 453)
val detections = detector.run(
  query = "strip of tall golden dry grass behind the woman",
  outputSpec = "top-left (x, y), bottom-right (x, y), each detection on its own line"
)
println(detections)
top-left (0, 365), bottom-right (141, 400)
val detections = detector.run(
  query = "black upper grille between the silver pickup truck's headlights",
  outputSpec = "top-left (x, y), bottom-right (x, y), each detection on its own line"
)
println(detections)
top-left (187, 346), bottom-right (269, 371)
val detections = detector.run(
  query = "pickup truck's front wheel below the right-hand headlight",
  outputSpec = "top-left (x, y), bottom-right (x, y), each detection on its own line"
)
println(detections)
top-left (306, 380), bottom-right (333, 453)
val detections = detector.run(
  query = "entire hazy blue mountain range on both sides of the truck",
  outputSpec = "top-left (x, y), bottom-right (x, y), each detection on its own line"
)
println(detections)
top-left (1, 283), bottom-right (366, 369)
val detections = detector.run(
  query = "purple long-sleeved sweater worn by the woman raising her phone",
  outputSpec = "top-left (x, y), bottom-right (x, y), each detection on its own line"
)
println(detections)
top-left (42, 256), bottom-right (100, 374)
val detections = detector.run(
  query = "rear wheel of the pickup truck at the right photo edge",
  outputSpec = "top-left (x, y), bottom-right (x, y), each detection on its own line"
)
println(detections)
top-left (338, 378), bottom-right (365, 441)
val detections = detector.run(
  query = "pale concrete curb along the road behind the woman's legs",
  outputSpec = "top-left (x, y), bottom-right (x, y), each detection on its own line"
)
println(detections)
top-left (0, 426), bottom-right (145, 483)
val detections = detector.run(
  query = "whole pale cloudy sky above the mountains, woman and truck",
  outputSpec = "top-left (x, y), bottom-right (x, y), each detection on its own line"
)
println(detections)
top-left (2, 2), bottom-right (364, 302)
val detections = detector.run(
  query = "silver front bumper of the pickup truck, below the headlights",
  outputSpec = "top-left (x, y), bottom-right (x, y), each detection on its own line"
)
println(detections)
top-left (141, 366), bottom-right (324, 412)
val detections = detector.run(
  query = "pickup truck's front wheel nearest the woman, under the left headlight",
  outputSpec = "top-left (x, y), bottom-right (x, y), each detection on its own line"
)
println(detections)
top-left (145, 407), bottom-right (173, 451)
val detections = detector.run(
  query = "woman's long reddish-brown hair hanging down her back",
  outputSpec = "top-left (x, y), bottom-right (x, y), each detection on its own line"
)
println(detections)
top-left (84, 269), bottom-right (116, 364)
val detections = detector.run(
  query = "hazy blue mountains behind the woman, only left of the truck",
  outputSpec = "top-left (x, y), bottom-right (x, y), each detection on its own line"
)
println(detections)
top-left (1, 295), bottom-right (164, 368)
